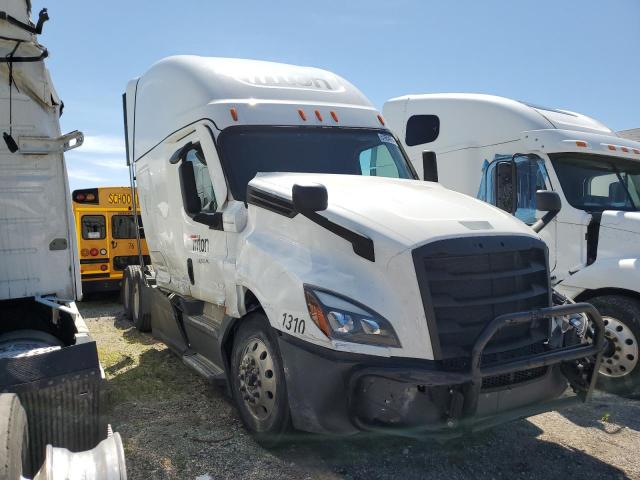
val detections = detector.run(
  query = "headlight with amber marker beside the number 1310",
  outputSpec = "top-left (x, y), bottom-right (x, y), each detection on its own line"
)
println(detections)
top-left (304, 286), bottom-right (400, 347)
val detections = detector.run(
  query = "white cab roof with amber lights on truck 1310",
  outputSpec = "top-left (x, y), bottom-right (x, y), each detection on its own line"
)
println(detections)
top-left (127, 55), bottom-right (380, 158)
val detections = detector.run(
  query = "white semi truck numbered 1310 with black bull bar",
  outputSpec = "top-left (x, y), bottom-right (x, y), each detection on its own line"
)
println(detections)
top-left (123, 56), bottom-right (604, 443)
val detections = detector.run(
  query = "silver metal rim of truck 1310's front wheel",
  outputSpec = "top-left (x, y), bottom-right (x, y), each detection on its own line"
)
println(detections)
top-left (238, 338), bottom-right (276, 420)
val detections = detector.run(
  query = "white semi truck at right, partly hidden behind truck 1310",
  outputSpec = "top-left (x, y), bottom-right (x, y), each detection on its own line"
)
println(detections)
top-left (383, 94), bottom-right (640, 396)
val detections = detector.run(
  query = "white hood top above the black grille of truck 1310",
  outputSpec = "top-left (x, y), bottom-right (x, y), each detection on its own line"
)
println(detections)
top-left (250, 173), bottom-right (537, 247)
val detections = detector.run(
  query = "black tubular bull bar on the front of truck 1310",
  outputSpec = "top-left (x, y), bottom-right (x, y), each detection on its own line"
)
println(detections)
top-left (348, 303), bottom-right (605, 440)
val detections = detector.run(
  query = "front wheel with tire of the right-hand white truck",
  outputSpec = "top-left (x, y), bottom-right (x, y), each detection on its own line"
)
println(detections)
top-left (587, 295), bottom-right (640, 397)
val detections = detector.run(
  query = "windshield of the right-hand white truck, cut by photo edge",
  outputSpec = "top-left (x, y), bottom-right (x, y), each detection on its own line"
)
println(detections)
top-left (550, 153), bottom-right (640, 212)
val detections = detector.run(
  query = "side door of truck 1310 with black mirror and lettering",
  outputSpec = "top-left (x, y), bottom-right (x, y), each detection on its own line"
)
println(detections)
top-left (175, 127), bottom-right (227, 305)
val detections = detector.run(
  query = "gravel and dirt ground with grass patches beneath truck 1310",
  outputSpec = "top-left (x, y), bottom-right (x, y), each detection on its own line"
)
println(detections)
top-left (79, 297), bottom-right (640, 480)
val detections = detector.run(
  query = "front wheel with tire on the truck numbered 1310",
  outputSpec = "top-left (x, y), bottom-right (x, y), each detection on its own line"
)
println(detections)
top-left (230, 312), bottom-right (291, 447)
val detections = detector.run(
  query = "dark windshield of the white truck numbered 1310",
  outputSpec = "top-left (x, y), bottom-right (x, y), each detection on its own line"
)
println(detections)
top-left (218, 126), bottom-right (417, 201)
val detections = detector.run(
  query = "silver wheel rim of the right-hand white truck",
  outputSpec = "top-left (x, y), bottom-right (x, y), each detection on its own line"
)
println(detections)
top-left (600, 317), bottom-right (638, 377)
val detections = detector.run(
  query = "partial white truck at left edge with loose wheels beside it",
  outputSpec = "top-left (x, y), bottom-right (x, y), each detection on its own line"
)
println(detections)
top-left (0, 0), bottom-right (126, 480)
